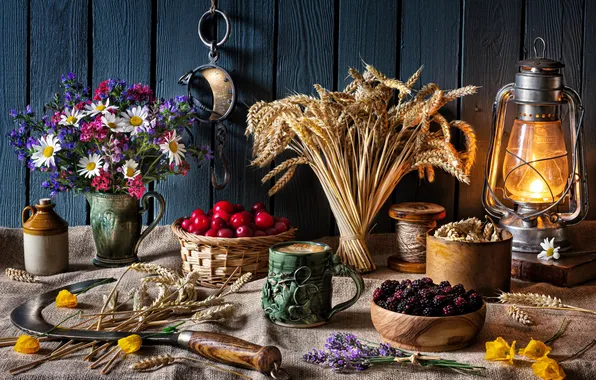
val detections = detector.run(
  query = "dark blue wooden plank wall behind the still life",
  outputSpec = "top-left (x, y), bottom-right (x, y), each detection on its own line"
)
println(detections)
top-left (0, 0), bottom-right (596, 238)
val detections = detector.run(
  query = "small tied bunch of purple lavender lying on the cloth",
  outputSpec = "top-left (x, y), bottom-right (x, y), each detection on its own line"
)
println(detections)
top-left (303, 332), bottom-right (484, 375)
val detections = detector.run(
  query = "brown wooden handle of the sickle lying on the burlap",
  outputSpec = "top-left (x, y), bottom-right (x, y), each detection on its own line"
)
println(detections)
top-left (178, 331), bottom-right (281, 375)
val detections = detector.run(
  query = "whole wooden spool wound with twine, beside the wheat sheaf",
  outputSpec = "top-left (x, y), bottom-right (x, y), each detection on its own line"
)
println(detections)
top-left (387, 202), bottom-right (446, 273)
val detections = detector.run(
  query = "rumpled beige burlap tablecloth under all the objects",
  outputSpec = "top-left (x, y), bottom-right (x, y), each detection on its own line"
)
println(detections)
top-left (0, 227), bottom-right (596, 380)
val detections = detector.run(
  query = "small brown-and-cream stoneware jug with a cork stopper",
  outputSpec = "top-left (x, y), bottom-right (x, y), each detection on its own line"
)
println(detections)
top-left (21, 198), bottom-right (68, 276)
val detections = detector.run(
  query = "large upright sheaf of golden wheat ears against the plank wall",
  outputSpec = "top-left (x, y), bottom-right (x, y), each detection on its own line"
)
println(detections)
top-left (246, 65), bottom-right (477, 272)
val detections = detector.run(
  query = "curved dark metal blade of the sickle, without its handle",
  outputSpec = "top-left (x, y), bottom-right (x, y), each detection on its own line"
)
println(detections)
top-left (10, 278), bottom-right (178, 344)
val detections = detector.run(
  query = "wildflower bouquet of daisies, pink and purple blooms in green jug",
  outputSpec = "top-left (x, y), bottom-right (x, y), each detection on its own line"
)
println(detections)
top-left (8, 73), bottom-right (211, 198)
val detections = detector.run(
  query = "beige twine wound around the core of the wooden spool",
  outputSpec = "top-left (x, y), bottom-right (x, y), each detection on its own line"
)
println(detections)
top-left (395, 220), bottom-right (437, 263)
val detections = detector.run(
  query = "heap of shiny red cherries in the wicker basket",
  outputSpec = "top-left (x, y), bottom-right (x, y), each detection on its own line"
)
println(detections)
top-left (181, 201), bottom-right (291, 238)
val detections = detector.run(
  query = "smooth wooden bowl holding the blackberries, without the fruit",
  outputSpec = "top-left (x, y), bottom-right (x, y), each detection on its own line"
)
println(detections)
top-left (370, 301), bottom-right (486, 352)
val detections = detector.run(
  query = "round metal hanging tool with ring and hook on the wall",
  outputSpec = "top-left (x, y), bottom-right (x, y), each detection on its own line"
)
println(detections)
top-left (178, 9), bottom-right (236, 190)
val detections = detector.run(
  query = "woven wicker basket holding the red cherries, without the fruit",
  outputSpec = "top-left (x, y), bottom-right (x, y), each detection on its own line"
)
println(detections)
top-left (172, 218), bottom-right (296, 287)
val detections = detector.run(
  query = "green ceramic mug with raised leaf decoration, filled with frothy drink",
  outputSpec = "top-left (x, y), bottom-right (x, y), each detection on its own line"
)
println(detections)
top-left (261, 241), bottom-right (364, 327)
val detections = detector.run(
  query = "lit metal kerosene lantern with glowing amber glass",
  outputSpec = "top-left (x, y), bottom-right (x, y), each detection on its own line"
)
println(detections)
top-left (482, 38), bottom-right (588, 253)
